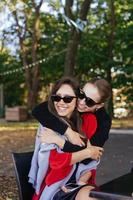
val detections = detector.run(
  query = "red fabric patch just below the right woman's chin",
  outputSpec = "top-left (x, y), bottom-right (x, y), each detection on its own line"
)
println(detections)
top-left (82, 113), bottom-right (97, 139)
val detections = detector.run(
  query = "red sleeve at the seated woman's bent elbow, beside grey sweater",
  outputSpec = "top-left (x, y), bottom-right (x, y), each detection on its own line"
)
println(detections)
top-left (46, 149), bottom-right (72, 186)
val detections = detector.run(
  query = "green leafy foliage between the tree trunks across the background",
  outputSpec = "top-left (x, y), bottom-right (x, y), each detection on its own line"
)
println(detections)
top-left (0, 0), bottom-right (133, 115)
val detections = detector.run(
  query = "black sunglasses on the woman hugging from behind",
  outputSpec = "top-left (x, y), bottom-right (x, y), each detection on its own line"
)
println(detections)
top-left (78, 90), bottom-right (99, 107)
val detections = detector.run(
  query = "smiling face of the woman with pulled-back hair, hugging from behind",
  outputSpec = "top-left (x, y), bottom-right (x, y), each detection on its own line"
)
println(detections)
top-left (78, 83), bottom-right (104, 112)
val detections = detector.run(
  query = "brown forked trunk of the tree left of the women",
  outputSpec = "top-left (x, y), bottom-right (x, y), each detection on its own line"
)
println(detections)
top-left (13, 0), bottom-right (43, 111)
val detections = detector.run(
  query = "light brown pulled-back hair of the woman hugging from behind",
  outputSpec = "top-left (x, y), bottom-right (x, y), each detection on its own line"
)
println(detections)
top-left (89, 78), bottom-right (111, 103)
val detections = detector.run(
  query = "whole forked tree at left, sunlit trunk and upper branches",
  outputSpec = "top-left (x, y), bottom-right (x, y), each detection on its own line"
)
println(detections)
top-left (1, 0), bottom-right (43, 110)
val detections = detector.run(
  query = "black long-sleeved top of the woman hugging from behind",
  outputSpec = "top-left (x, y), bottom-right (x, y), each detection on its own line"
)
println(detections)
top-left (32, 102), bottom-right (111, 164)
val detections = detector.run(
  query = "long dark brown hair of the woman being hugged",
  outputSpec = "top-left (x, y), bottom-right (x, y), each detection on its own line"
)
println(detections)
top-left (48, 77), bottom-right (81, 132)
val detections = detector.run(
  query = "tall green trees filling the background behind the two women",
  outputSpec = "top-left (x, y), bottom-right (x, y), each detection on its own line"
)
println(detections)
top-left (0, 0), bottom-right (133, 116)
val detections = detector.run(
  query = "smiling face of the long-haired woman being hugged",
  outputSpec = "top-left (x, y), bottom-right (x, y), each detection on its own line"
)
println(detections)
top-left (54, 84), bottom-right (76, 118)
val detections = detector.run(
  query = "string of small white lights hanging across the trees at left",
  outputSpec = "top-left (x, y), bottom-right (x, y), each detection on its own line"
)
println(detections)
top-left (0, 49), bottom-right (66, 76)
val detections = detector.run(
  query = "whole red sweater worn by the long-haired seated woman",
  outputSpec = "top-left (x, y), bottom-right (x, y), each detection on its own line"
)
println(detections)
top-left (32, 113), bottom-right (97, 200)
